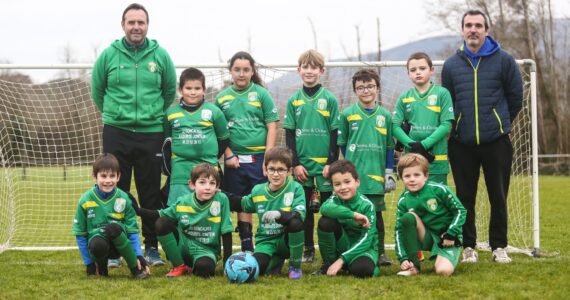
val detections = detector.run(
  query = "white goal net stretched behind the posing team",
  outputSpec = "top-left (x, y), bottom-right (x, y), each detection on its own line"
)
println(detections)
top-left (0, 61), bottom-right (539, 253)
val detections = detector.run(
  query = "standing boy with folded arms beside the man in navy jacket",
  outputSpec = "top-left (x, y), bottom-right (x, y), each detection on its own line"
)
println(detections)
top-left (392, 52), bottom-right (454, 184)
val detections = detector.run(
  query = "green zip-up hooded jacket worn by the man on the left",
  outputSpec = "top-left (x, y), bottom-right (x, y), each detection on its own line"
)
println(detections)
top-left (91, 38), bottom-right (176, 132)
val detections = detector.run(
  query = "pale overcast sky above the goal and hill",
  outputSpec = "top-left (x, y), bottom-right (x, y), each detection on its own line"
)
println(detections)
top-left (0, 0), bottom-right (570, 81)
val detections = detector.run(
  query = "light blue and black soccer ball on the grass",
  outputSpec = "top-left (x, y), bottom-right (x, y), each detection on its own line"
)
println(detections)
top-left (224, 252), bottom-right (259, 283)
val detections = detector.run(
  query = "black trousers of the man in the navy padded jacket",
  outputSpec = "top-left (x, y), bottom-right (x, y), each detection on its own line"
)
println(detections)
top-left (448, 135), bottom-right (513, 250)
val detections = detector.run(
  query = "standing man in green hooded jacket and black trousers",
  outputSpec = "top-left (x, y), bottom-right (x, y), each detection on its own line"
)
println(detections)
top-left (91, 3), bottom-right (176, 266)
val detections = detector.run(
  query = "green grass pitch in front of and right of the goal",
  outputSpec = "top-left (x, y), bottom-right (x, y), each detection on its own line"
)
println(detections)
top-left (0, 176), bottom-right (570, 299)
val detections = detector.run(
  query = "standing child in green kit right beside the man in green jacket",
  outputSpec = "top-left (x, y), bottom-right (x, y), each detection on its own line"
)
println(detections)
top-left (163, 68), bottom-right (230, 206)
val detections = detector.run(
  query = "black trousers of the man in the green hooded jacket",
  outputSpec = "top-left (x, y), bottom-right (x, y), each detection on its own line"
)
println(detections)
top-left (103, 125), bottom-right (164, 247)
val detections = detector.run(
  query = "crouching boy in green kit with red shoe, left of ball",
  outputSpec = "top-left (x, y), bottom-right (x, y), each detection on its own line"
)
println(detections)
top-left (139, 163), bottom-right (233, 278)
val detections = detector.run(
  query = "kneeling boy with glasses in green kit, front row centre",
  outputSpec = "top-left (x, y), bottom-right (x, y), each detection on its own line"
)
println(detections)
top-left (226, 147), bottom-right (305, 279)
